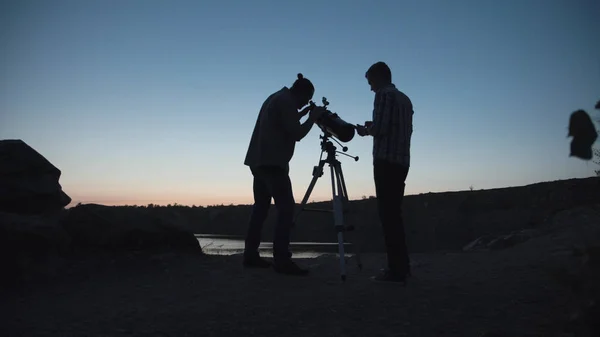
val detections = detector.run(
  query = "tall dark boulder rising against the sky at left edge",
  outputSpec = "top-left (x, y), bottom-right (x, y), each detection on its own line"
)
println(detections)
top-left (0, 139), bottom-right (71, 214)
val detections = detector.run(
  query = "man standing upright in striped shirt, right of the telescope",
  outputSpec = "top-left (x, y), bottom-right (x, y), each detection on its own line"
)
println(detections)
top-left (357, 62), bottom-right (413, 282)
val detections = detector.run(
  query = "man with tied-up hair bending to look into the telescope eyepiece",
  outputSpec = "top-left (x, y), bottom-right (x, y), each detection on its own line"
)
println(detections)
top-left (244, 74), bottom-right (324, 275)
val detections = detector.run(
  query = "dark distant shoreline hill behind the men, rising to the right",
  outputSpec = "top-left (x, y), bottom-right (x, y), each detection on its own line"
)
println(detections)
top-left (58, 177), bottom-right (600, 252)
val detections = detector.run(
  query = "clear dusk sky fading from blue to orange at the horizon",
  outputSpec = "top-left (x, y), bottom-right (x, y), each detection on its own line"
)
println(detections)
top-left (0, 0), bottom-right (600, 205)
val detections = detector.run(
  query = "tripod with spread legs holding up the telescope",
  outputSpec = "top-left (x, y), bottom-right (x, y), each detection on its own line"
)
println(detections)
top-left (294, 130), bottom-right (362, 281)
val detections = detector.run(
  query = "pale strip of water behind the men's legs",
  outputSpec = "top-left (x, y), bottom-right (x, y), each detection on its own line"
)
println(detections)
top-left (196, 234), bottom-right (352, 258)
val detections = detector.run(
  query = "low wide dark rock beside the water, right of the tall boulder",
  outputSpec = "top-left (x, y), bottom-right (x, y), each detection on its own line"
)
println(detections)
top-left (64, 204), bottom-right (202, 252)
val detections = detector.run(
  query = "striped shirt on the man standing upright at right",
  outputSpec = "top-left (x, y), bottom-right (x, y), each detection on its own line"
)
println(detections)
top-left (369, 84), bottom-right (414, 167)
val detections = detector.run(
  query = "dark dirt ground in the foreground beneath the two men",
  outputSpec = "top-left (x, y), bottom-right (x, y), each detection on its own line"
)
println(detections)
top-left (0, 238), bottom-right (580, 337)
